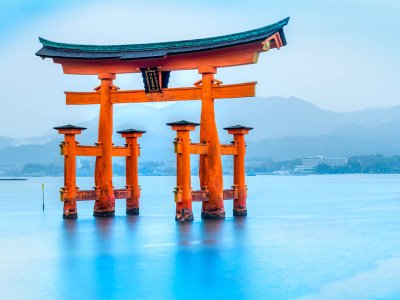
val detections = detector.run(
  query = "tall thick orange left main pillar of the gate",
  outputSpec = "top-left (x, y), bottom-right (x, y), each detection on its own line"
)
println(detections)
top-left (93, 73), bottom-right (115, 217)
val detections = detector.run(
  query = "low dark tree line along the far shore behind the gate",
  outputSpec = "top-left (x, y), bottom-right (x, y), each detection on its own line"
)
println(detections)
top-left (0, 154), bottom-right (400, 176)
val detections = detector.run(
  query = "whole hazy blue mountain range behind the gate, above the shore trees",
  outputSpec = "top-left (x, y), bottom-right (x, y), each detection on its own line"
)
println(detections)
top-left (0, 97), bottom-right (400, 165)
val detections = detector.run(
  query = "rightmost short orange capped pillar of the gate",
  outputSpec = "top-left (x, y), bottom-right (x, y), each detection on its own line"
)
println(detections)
top-left (224, 125), bottom-right (253, 217)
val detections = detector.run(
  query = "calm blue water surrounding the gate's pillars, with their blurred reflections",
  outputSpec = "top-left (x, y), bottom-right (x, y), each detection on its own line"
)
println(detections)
top-left (0, 175), bottom-right (400, 299)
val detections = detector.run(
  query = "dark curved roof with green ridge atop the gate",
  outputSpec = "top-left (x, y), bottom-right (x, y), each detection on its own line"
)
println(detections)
top-left (36, 18), bottom-right (289, 60)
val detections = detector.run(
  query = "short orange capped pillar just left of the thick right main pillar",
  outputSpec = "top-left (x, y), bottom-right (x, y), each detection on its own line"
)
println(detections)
top-left (167, 121), bottom-right (199, 221)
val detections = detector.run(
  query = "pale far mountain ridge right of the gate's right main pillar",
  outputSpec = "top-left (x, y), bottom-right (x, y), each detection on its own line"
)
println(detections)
top-left (216, 97), bottom-right (400, 140)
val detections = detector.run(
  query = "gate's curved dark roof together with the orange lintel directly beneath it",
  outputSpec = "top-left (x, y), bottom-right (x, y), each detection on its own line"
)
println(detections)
top-left (36, 18), bottom-right (289, 74)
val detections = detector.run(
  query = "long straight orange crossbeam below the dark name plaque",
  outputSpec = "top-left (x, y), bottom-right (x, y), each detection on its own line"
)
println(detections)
top-left (65, 82), bottom-right (257, 105)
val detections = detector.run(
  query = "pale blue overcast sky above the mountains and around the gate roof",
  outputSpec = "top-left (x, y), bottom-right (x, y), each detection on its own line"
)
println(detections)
top-left (0, 0), bottom-right (400, 138)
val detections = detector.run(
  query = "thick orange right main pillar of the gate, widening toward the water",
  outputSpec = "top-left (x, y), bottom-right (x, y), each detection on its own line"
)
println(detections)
top-left (199, 67), bottom-right (225, 219)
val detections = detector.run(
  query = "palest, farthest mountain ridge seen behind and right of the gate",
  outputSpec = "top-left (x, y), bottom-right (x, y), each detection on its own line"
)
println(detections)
top-left (52, 97), bottom-right (400, 144)
